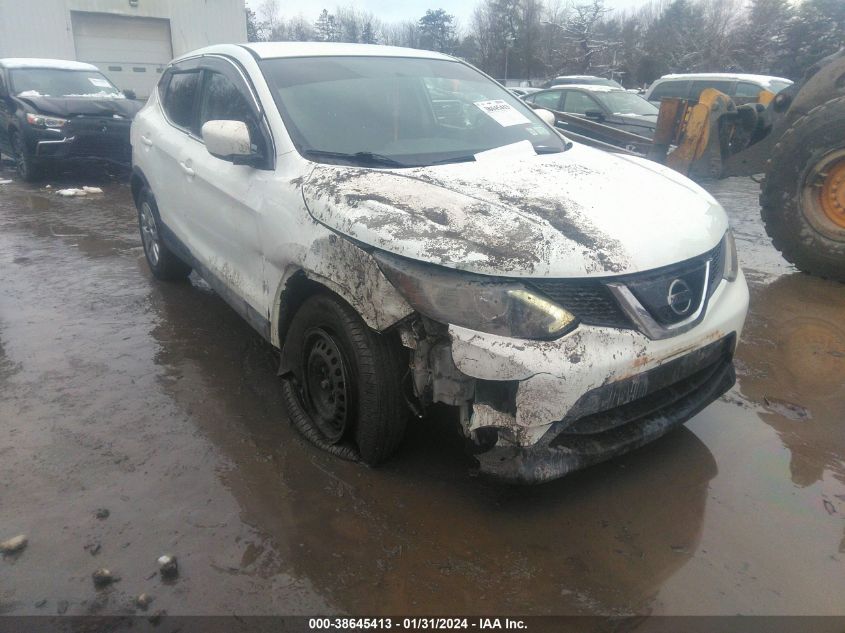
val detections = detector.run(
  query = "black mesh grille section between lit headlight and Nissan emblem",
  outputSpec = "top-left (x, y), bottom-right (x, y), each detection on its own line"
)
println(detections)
top-left (528, 279), bottom-right (634, 329)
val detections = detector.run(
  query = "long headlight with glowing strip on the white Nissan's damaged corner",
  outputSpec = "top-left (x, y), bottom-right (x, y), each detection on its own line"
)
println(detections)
top-left (375, 252), bottom-right (578, 339)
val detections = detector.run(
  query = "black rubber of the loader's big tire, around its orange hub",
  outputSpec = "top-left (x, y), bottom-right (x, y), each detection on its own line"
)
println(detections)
top-left (760, 97), bottom-right (845, 282)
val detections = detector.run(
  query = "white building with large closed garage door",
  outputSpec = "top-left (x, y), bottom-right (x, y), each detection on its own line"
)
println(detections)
top-left (0, 0), bottom-right (246, 97)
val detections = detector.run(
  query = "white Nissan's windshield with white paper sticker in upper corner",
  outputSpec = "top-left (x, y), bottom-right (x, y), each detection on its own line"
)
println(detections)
top-left (261, 56), bottom-right (565, 167)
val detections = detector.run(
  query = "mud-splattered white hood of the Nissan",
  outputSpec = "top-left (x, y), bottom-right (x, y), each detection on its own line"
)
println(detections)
top-left (303, 144), bottom-right (728, 277)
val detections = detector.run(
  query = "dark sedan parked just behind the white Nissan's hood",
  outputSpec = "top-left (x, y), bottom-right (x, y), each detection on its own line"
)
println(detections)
top-left (524, 86), bottom-right (660, 151)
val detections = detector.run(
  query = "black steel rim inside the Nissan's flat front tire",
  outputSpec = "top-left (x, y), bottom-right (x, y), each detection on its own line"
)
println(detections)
top-left (302, 328), bottom-right (350, 444)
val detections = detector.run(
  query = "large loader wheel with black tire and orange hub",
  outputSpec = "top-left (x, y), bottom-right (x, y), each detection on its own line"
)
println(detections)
top-left (760, 97), bottom-right (845, 282)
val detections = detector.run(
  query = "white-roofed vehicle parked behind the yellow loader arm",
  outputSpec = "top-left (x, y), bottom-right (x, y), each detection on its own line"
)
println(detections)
top-left (645, 73), bottom-right (792, 106)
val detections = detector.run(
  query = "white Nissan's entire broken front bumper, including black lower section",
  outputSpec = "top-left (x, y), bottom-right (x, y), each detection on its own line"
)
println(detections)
top-left (449, 273), bottom-right (748, 483)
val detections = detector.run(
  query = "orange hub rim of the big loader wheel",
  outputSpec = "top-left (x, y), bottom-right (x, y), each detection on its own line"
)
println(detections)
top-left (802, 150), bottom-right (845, 242)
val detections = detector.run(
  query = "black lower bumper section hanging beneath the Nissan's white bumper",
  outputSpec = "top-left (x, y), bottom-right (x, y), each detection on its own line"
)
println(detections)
top-left (475, 335), bottom-right (736, 484)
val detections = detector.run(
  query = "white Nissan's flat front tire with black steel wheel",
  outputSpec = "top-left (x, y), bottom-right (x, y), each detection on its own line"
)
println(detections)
top-left (282, 292), bottom-right (408, 466)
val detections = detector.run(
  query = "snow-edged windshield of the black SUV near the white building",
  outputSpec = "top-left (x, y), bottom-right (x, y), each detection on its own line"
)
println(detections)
top-left (9, 68), bottom-right (123, 97)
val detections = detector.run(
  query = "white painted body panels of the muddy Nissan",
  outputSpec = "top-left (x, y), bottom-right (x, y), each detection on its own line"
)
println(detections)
top-left (132, 43), bottom-right (748, 460)
